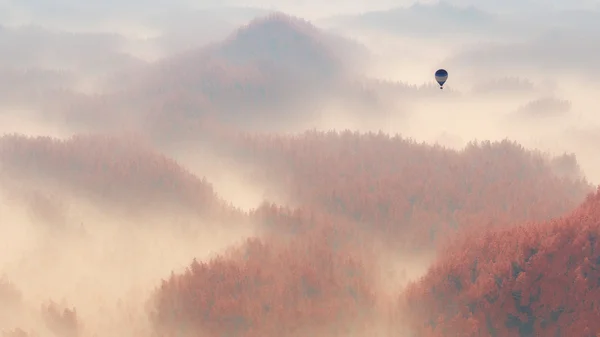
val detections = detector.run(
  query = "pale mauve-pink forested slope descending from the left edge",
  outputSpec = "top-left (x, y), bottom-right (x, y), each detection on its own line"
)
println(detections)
top-left (0, 135), bottom-right (244, 220)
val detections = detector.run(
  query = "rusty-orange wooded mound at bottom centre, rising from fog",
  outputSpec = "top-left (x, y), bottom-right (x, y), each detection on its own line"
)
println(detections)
top-left (151, 207), bottom-right (375, 337)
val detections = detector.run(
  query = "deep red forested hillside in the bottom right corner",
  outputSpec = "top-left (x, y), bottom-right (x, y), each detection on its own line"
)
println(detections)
top-left (401, 189), bottom-right (600, 337)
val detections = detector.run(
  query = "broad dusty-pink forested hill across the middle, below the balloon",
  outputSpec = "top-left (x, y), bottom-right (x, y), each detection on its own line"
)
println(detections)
top-left (233, 131), bottom-right (591, 249)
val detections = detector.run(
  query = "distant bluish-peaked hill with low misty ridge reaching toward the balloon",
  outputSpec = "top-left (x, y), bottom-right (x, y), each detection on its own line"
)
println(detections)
top-left (22, 13), bottom-right (464, 142)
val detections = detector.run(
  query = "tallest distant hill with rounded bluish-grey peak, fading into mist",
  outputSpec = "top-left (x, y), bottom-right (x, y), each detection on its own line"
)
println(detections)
top-left (75, 13), bottom-right (372, 135)
